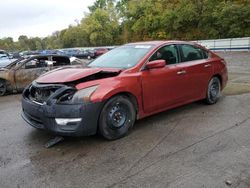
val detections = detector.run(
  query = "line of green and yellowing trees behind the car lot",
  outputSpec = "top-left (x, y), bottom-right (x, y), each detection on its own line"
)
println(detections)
top-left (0, 0), bottom-right (250, 50)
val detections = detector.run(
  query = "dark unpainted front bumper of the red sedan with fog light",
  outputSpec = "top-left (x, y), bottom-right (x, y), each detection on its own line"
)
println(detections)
top-left (22, 85), bottom-right (103, 136)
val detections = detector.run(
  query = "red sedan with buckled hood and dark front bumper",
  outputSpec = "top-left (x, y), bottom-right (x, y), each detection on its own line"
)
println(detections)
top-left (22, 41), bottom-right (228, 140)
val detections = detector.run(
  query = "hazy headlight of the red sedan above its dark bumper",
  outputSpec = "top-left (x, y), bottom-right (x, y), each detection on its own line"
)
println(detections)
top-left (72, 85), bottom-right (98, 103)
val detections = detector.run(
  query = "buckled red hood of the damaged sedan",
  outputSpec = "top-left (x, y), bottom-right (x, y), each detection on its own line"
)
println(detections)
top-left (36, 67), bottom-right (121, 84)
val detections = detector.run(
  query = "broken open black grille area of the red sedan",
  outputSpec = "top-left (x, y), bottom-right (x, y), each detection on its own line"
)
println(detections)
top-left (29, 85), bottom-right (60, 104)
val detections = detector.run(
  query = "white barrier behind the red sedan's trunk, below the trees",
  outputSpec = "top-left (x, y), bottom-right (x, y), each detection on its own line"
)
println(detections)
top-left (194, 37), bottom-right (250, 51)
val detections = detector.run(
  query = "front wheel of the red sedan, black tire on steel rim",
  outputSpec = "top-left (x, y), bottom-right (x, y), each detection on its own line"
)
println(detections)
top-left (98, 95), bottom-right (136, 140)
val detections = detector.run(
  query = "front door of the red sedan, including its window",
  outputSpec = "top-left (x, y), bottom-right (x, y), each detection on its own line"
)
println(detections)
top-left (141, 45), bottom-right (187, 113)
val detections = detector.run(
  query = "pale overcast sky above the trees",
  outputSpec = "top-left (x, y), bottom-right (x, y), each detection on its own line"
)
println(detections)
top-left (0, 0), bottom-right (94, 40)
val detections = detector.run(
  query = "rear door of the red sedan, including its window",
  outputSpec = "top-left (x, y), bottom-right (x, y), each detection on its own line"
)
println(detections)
top-left (179, 44), bottom-right (213, 100)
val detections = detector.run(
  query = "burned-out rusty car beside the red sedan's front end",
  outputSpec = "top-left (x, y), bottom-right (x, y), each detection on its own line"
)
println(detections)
top-left (0, 55), bottom-right (82, 96)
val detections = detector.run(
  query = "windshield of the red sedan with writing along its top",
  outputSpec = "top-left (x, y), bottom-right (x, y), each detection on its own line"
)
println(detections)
top-left (89, 45), bottom-right (153, 69)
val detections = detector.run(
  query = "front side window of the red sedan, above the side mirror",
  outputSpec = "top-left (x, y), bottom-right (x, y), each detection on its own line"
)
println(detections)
top-left (149, 44), bottom-right (179, 65)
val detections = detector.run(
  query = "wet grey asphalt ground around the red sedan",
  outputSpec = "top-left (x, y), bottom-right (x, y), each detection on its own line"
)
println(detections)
top-left (0, 52), bottom-right (250, 188)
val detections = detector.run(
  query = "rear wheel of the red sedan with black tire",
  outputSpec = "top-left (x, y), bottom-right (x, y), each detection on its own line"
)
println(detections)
top-left (206, 77), bottom-right (221, 104)
